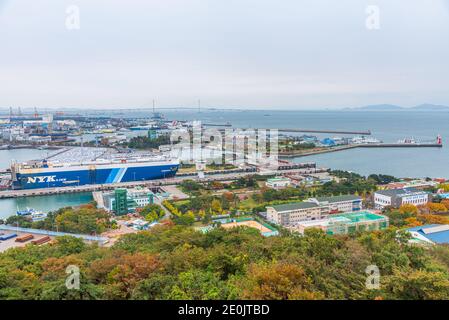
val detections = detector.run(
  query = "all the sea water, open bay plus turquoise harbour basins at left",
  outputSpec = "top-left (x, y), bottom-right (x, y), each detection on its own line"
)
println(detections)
top-left (0, 109), bottom-right (449, 218)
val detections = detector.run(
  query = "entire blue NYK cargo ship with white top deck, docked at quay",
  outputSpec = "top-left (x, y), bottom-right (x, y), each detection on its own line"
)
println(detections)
top-left (11, 148), bottom-right (179, 189)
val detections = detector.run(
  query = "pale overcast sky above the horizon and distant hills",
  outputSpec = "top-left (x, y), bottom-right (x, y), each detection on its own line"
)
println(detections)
top-left (0, 0), bottom-right (449, 109)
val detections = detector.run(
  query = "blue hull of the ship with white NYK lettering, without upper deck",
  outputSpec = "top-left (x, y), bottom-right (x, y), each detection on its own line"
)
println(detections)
top-left (14, 163), bottom-right (179, 189)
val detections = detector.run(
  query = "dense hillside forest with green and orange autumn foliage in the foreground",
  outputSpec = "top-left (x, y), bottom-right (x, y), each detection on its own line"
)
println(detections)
top-left (0, 224), bottom-right (449, 299)
